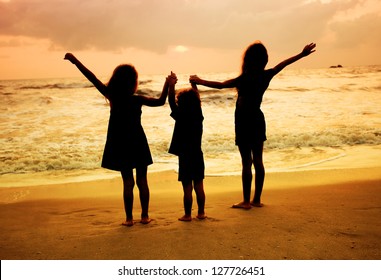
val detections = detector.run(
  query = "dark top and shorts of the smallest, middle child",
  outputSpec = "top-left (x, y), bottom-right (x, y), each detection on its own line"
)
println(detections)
top-left (169, 100), bottom-right (205, 182)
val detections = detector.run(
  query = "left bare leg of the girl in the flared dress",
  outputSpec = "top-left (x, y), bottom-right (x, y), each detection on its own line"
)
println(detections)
top-left (121, 170), bottom-right (135, 226)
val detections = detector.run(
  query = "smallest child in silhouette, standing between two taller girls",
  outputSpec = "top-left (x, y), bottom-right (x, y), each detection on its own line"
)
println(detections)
top-left (168, 74), bottom-right (206, 222)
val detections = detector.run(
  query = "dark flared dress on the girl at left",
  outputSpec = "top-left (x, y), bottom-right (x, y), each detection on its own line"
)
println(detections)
top-left (102, 95), bottom-right (152, 171)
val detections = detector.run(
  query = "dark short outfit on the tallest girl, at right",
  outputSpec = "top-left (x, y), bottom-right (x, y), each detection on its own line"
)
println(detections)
top-left (235, 69), bottom-right (275, 146)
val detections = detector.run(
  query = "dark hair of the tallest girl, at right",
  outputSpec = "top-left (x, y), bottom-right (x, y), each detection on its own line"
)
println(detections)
top-left (242, 41), bottom-right (269, 74)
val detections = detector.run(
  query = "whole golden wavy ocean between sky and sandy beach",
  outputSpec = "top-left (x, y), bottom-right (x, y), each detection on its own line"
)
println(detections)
top-left (0, 65), bottom-right (381, 185)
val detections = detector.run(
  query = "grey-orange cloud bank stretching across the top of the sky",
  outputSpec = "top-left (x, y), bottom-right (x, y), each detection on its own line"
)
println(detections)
top-left (0, 0), bottom-right (380, 53)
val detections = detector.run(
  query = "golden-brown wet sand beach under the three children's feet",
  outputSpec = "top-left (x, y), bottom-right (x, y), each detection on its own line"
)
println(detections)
top-left (0, 163), bottom-right (381, 260)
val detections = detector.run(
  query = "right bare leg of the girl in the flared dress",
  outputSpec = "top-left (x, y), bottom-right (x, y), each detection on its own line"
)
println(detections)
top-left (136, 166), bottom-right (151, 224)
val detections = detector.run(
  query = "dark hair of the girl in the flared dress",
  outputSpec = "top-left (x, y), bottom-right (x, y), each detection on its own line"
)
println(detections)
top-left (107, 64), bottom-right (138, 99)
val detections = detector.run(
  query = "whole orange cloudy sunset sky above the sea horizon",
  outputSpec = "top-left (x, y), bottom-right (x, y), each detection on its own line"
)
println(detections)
top-left (0, 0), bottom-right (381, 80)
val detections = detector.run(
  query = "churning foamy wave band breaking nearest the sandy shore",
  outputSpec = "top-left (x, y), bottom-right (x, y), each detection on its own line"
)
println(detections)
top-left (0, 128), bottom-right (381, 174)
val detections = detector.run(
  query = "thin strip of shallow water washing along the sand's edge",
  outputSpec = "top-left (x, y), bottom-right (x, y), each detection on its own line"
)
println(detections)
top-left (0, 145), bottom-right (381, 189)
